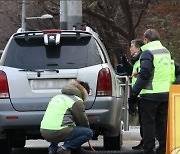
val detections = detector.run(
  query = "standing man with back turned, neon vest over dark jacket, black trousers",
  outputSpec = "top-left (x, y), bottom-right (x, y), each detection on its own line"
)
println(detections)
top-left (130, 29), bottom-right (171, 154)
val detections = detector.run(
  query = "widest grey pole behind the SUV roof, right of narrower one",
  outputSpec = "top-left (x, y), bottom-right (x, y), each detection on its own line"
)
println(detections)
top-left (67, 0), bottom-right (82, 30)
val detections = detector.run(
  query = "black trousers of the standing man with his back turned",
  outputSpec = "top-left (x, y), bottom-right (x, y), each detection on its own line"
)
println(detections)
top-left (139, 99), bottom-right (168, 154)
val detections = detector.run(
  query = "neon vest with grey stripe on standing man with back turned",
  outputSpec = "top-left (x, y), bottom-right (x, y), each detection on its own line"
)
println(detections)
top-left (140, 41), bottom-right (171, 94)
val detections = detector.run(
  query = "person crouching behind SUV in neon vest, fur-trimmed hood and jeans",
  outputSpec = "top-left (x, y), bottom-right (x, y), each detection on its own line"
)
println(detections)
top-left (40, 80), bottom-right (93, 154)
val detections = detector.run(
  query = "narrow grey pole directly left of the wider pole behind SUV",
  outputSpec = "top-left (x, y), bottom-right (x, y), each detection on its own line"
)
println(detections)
top-left (60, 0), bottom-right (68, 30)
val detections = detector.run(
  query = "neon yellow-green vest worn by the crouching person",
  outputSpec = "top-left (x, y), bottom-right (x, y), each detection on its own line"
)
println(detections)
top-left (41, 94), bottom-right (82, 130)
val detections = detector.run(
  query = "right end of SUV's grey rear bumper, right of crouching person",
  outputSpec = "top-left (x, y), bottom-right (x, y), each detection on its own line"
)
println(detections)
top-left (86, 97), bottom-right (123, 136)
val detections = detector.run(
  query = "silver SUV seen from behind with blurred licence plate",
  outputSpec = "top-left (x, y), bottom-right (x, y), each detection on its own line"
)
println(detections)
top-left (0, 27), bottom-right (123, 154)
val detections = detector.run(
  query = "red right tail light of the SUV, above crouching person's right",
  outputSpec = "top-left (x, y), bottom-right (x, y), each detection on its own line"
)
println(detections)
top-left (96, 68), bottom-right (112, 96)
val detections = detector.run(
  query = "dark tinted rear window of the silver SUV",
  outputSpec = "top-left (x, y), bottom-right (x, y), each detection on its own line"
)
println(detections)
top-left (2, 35), bottom-right (102, 69)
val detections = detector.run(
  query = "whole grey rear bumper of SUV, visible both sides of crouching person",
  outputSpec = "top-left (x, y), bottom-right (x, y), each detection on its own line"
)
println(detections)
top-left (0, 97), bottom-right (123, 135)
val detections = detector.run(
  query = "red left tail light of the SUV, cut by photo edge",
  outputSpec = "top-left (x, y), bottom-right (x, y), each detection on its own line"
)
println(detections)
top-left (0, 71), bottom-right (9, 98)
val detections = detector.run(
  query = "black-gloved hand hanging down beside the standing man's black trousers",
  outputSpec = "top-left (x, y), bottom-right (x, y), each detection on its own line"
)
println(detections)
top-left (128, 94), bottom-right (138, 116)
